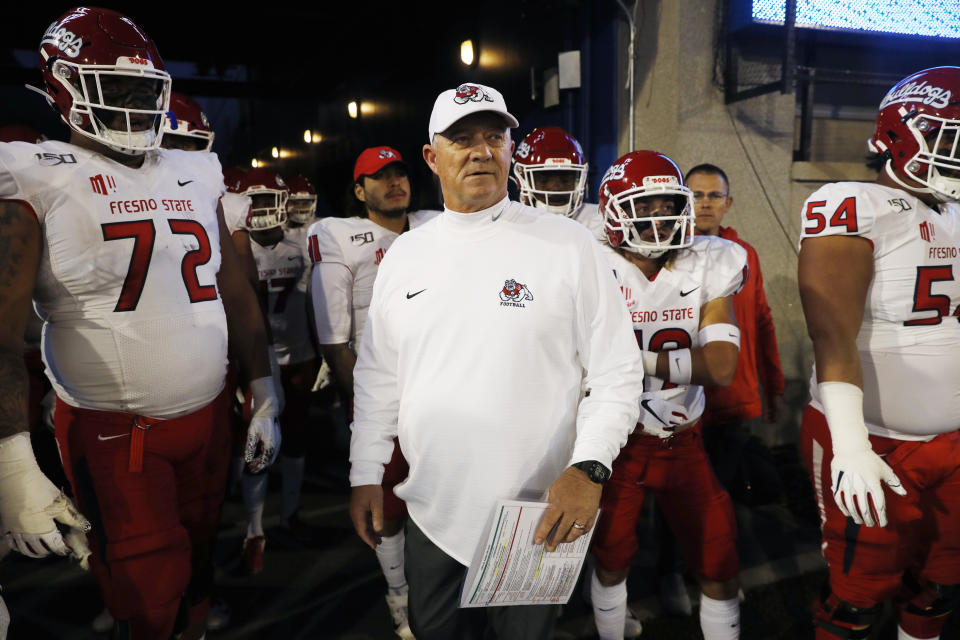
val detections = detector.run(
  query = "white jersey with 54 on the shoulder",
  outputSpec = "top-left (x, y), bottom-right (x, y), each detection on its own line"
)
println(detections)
top-left (800, 182), bottom-right (960, 440)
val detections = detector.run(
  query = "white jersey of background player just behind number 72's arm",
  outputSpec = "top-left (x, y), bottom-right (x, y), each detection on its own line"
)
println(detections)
top-left (250, 228), bottom-right (315, 365)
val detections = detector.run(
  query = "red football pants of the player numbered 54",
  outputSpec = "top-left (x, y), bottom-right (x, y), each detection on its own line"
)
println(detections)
top-left (800, 406), bottom-right (960, 608)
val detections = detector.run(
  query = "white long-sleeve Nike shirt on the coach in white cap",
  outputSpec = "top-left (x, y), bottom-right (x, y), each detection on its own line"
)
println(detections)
top-left (350, 199), bottom-right (643, 564)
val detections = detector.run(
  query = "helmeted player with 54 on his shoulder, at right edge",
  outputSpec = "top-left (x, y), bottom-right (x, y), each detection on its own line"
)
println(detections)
top-left (799, 67), bottom-right (960, 640)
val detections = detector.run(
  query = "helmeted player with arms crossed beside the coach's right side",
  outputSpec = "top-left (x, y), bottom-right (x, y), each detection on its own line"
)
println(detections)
top-left (591, 151), bottom-right (747, 640)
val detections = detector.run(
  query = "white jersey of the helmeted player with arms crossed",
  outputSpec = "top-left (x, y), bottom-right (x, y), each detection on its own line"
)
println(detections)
top-left (604, 236), bottom-right (747, 421)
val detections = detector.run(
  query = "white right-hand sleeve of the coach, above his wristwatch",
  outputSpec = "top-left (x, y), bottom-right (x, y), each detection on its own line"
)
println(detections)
top-left (570, 230), bottom-right (643, 468)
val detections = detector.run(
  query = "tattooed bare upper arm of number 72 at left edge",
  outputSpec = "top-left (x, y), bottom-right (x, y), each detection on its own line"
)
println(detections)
top-left (0, 201), bottom-right (41, 440)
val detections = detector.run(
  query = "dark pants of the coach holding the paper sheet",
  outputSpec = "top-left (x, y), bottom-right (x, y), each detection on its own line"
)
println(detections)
top-left (404, 518), bottom-right (559, 640)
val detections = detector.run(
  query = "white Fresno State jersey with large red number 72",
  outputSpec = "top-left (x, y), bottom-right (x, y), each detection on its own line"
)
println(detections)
top-left (0, 142), bottom-right (227, 418)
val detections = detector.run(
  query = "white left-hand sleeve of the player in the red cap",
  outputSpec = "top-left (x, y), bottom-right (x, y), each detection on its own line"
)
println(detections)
top-left (307, 218), bottom-right (354, 344)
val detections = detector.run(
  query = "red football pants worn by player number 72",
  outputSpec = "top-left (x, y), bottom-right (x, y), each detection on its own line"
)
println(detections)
top-left (55, 393), bottom-right (230, 640)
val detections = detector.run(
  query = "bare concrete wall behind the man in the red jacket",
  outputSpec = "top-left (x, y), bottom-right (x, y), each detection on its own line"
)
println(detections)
top-left (619, 0), bottom-right (872, 444)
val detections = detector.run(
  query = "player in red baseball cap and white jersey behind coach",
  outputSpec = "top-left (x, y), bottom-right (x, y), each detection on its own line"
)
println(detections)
top-left (307, 147), bottom-right (436, 638)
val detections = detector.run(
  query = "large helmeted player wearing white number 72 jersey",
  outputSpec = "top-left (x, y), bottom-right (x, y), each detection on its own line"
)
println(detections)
top-left (0, 7), bottom-right (280, 640)
